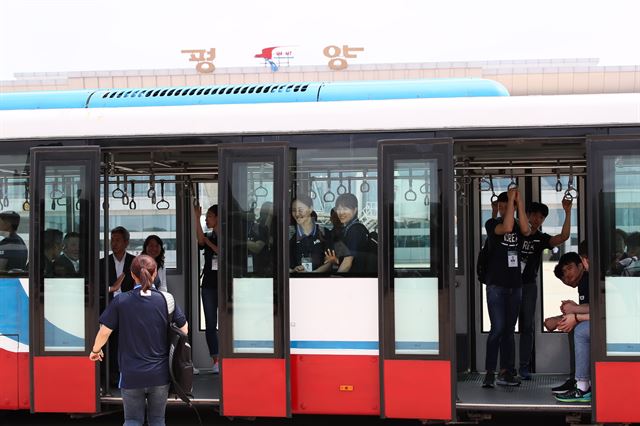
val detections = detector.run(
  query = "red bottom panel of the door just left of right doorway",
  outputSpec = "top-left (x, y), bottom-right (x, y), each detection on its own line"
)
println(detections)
top-left (384, 360), bottom-right (452, 420)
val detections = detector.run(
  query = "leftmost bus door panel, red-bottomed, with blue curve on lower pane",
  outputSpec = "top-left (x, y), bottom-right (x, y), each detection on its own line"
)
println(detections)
top-left (29, 146), bottom-right (100, 413)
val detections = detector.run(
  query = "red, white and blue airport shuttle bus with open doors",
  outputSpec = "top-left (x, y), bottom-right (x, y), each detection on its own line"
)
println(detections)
top-left (0, 79), bottom-right (640, 423)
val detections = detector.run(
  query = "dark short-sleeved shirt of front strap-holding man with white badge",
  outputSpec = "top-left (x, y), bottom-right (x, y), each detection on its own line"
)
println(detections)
top-left (484, 218), bottom-right (522, 288)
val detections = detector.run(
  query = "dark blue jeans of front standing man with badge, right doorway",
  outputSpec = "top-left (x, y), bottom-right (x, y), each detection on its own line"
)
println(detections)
top-left (485, 285), bottom-right (522, 371)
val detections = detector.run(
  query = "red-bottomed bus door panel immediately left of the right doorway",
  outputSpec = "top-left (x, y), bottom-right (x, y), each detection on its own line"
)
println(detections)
top-left (378, 139), bottom-right (455, 420)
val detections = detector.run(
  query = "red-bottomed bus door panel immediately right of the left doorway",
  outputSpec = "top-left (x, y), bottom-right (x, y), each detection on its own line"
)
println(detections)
top-left (218, 143), bottom-right (290, 417)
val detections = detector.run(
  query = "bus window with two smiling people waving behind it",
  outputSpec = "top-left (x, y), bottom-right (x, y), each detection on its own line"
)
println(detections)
top-left (289, 147), bottom-right (376, 277)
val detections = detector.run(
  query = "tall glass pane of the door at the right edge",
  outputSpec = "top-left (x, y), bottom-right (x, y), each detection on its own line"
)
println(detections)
top-left (599, 155), bottom-right (640, 356)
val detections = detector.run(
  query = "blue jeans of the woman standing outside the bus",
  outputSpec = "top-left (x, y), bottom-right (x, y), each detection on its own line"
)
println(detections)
top-left (122, 384), bottom-right (169, 426)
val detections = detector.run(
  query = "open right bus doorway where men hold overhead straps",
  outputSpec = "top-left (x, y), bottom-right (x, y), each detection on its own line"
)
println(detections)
top-left (455, 138), bottom-right (590, 411)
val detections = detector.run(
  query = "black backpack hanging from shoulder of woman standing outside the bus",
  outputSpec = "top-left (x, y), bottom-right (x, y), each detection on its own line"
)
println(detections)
top-left (160, 291), bottom-right (193, 405)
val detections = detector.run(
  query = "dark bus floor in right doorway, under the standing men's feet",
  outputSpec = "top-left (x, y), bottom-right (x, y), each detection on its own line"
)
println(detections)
top-left (456, 373), bottom-right (591, 413)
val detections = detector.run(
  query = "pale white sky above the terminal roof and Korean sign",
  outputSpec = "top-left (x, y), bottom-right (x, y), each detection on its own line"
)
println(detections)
top-left (0, 0), bottom-right (640, 80)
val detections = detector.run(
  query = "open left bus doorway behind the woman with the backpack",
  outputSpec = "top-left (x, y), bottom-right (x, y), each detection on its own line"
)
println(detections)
top-left (100, 145), bottom-right (220, 404)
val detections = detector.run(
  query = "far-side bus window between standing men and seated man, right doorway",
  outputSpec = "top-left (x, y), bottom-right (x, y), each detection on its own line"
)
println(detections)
top-left (540, 176), bottom-right (580, 332)
